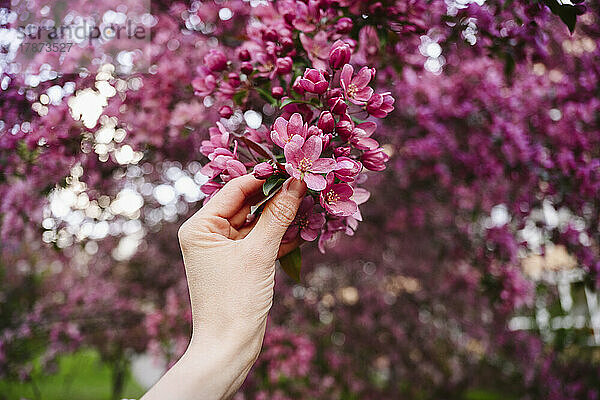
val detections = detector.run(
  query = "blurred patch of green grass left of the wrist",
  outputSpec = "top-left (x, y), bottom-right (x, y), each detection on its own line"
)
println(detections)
top-left (0, 350), bottom-right (144, 400)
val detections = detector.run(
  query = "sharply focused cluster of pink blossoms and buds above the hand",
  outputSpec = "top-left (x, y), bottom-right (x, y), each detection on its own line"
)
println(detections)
top-left (196, 40), bottom-right (394, 251)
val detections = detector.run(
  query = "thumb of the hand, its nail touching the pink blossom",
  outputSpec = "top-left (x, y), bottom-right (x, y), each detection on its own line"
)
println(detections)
top-left (247, 178), bottom-right (306, 248)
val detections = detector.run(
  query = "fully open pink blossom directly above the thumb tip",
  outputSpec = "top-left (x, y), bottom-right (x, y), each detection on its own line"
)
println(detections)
top-left (283, 135), bottom-right (335, 191)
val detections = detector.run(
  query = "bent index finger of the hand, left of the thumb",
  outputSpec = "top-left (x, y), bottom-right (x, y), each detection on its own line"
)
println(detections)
top-left (199, 174), bottom-right (264, 218)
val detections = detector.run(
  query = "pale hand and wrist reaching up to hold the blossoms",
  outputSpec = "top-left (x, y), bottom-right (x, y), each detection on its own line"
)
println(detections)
top-left (142, 175), bottom-right (306, 400)
